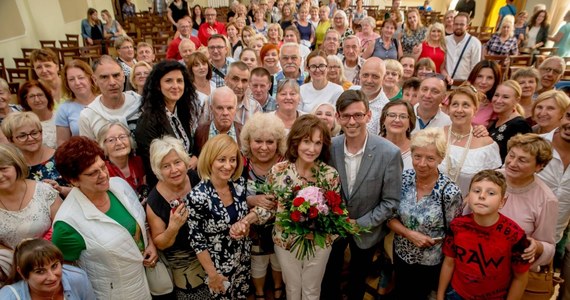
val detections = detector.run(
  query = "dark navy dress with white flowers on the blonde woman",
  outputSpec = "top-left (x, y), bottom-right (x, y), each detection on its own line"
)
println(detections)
top-left (185, 177), bottom-right (251, 300)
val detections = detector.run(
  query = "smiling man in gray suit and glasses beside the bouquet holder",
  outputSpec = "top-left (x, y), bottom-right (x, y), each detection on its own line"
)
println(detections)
top-left (321, 90), bottom-right (402, 300)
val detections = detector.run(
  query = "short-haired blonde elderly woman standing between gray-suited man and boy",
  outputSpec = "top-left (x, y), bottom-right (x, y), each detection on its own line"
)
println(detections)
top-left (388, 128), bottom-right (462, 299)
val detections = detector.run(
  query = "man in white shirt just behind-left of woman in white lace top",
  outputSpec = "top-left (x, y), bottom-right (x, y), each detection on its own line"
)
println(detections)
top-left (412, 73), bottom-right (451, 132)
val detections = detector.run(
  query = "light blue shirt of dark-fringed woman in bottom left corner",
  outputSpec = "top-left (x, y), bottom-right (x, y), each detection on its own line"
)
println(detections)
top-left (0, 265), bottom-right (95, 300)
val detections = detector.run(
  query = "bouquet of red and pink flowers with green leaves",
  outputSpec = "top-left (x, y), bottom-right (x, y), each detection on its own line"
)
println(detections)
top-left (266, 186), bottom-right (365, 260)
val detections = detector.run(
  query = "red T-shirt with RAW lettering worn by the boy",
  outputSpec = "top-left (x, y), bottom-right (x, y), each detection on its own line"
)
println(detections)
top-left (443, 214), bottom-right (530, 299)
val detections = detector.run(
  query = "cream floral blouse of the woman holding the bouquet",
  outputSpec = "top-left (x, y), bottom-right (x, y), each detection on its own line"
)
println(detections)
top-left (253, 161), bottom-right (340, 250)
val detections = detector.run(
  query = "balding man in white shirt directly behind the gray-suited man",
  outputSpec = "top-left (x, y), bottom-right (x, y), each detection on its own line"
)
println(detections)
top-left (350, 57), bottom-right (390, 134)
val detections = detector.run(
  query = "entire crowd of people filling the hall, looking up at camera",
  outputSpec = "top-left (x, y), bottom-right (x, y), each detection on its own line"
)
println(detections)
top-left (0, 0), bottom-right (570, 300)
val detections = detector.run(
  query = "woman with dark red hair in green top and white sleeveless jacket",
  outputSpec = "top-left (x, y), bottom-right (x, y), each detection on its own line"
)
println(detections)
top-left (52, 137), bottom-right (158, 300)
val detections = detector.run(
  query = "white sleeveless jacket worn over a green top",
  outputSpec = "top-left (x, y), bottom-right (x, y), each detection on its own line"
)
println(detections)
top-left (54, 177), bottom-right (151, 300)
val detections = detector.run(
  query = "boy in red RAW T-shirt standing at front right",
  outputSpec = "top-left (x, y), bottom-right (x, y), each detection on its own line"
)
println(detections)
top-left (437, 170), bottom-right (530, 300)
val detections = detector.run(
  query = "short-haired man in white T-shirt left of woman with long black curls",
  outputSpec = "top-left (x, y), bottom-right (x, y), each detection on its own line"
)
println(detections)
top-left (79, 55), bottom-right (141, 140)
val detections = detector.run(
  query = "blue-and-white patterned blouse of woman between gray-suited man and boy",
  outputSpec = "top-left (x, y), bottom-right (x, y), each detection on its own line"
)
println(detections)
top-left (394, 169), bottom-right (462, 266)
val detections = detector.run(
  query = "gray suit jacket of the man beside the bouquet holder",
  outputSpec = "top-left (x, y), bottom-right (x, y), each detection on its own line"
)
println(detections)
top-left (330, 134), bottom-right (403, 249)
